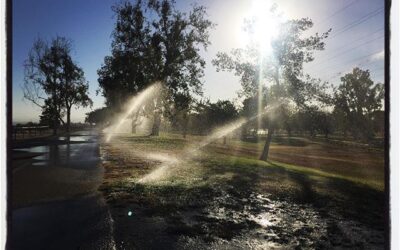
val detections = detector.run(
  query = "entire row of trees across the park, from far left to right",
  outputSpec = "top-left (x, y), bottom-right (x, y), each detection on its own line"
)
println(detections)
top-left (24, 0), bottom-right (383, 160)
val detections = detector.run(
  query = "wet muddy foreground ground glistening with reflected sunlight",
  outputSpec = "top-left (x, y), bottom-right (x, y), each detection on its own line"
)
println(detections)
top-left (108, 188), bottom-right (383, 249)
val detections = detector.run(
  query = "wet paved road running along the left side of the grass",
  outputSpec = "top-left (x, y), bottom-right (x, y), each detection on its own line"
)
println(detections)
top-left (10, 131), bottom-right (114, 250)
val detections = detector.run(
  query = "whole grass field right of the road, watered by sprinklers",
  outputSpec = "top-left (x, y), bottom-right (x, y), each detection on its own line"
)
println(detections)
top-left (97, 135), bottom-right (384, 249)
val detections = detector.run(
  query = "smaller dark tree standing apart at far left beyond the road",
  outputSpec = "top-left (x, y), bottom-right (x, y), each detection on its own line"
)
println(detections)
top-left (23, 37), bottom-right (92, 134)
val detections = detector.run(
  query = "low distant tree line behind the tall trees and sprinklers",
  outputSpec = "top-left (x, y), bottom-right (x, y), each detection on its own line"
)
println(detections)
top-left (86, 65), bottom-right (384, 142)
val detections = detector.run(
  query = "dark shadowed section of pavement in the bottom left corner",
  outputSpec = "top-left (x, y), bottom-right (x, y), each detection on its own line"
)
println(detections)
top-left (10, 195), bottom-right (114, 249)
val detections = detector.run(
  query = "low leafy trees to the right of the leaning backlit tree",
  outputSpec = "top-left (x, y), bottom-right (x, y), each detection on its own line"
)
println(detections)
top-left (238, 68), bottom-right (384, 141)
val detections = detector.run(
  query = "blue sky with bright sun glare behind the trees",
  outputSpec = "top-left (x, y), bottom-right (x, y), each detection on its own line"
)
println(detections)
top-left (12, 0), bottom-right (384, 123)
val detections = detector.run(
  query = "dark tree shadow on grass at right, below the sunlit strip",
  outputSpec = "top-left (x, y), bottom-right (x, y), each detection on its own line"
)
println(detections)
top-left (269, 162), bottom-right (385, 229)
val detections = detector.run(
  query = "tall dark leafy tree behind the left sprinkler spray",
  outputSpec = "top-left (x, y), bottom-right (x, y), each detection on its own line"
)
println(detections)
top-left (98, 0), bottom-right (213, 135)
